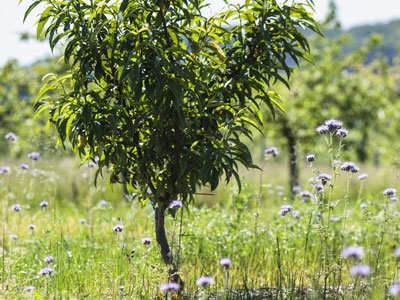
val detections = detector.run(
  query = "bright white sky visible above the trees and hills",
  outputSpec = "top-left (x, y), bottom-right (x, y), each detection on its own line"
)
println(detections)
top-left (0, 0), bottom-right (400, 65)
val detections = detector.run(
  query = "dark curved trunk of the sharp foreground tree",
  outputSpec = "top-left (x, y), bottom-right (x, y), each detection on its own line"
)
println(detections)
top-left (154, 201), bottom-right (184, 290)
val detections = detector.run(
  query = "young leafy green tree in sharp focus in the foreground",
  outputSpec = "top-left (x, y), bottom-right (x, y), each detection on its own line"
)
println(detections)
top-left (26, 0), bottom-right (319, 286)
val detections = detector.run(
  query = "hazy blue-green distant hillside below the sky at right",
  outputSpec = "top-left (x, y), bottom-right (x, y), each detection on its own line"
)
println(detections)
top-left (324, 20), bottom-right (400, 64)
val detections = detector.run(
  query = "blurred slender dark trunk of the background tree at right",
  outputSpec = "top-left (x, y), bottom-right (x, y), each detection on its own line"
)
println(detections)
top-left (282, 121), bottom-right (299, 200)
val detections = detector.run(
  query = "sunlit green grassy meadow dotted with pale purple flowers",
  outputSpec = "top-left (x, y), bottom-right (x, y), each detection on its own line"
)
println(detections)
top-left (0, 127), bottom-right (400, 299)
